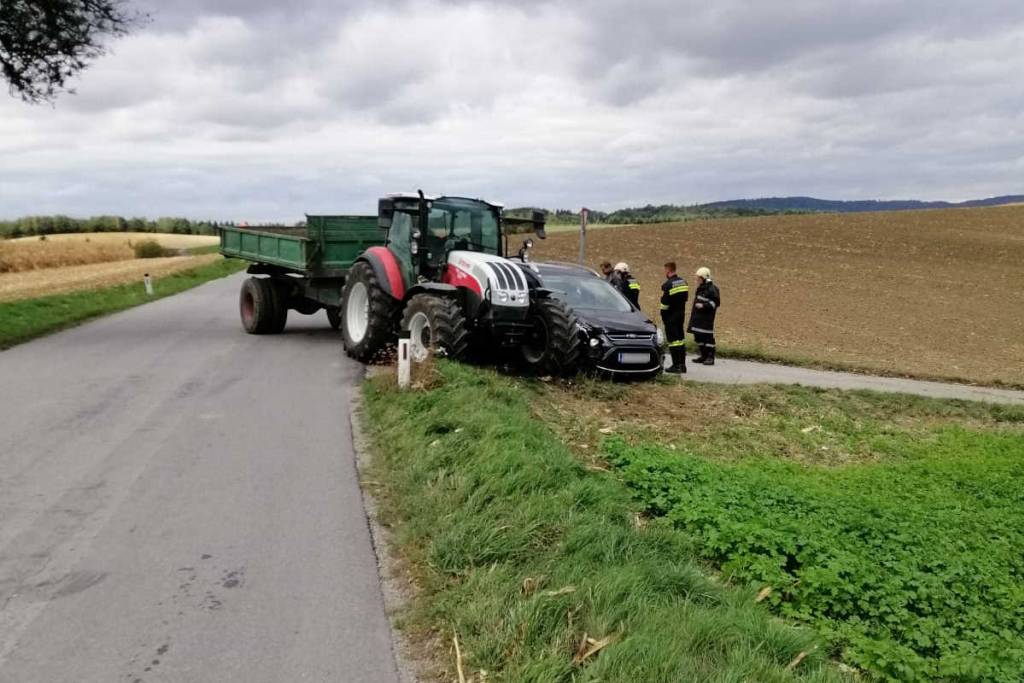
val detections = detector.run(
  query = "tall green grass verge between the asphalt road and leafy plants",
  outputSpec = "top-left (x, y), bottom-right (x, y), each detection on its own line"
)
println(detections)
top-left (365, 364), bottom-right (844, 683)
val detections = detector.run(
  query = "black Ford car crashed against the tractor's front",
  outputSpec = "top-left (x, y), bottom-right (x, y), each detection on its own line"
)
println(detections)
top-left (525, 262), bottom-right (662, 379)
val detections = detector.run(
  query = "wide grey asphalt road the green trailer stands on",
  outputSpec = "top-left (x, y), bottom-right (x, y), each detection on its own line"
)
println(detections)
top-left (0, 276), bottom-right (397, 683)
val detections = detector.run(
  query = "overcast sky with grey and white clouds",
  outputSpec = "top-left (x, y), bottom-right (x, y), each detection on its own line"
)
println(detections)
top-left (0, 0), bottom-right (1024, 221)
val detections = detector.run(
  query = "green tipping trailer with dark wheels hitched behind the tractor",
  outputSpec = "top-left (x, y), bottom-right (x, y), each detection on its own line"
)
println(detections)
top-left (218, 216), bottom-right (386, 334)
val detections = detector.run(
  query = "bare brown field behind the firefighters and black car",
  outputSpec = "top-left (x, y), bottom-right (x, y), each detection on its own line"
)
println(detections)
top-left (535, 206), bottom-right (1024, 386)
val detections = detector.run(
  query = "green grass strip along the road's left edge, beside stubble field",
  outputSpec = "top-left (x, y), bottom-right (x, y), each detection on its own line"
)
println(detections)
top-left (0, 259), bottom-right (245, 349)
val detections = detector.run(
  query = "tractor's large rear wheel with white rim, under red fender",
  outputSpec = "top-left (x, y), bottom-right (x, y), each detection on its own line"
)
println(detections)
top-left (341, 261), bottom-right (395, 362)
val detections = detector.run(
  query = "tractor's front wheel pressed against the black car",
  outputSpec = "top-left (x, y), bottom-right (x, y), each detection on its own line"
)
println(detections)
top-left (520, 297), bottom-right (580, 375)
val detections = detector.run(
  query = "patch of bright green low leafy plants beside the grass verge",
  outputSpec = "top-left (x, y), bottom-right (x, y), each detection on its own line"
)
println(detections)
top-left (605, 426), bottom-right (1024, 683)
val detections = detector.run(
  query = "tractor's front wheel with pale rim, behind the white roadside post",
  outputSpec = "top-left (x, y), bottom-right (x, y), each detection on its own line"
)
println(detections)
top-left (401, 294), bottom-right (469, 362)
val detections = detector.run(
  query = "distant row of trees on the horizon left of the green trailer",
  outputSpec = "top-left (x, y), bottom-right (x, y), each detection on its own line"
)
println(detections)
top-left (0, 215), bottom-right (232, 242)
